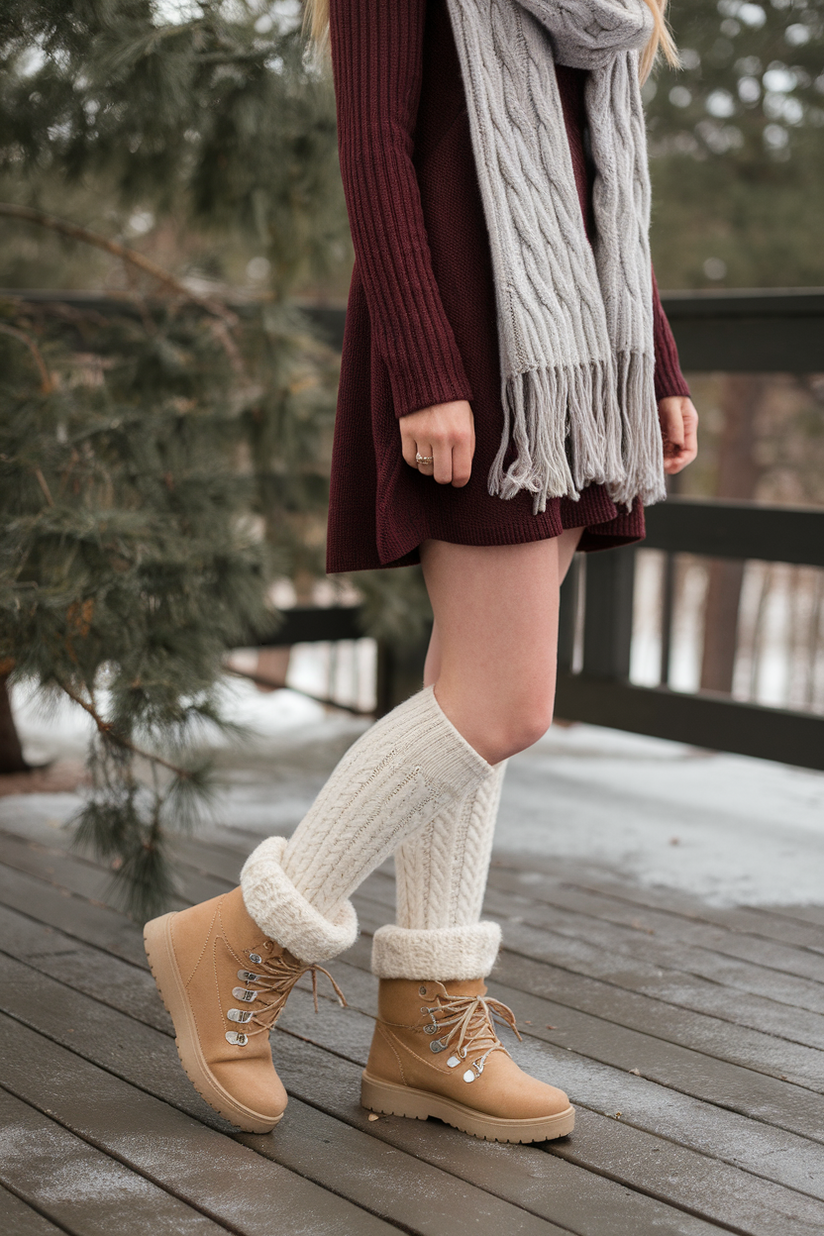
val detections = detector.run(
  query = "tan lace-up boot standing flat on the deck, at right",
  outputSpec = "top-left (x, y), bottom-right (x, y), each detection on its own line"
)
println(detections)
top-left (361, 979), bottom-right (574, 1142)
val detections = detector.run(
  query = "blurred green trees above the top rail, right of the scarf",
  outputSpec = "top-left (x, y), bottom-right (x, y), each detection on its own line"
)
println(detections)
top-left (645, 0), bottom-right (824, 288)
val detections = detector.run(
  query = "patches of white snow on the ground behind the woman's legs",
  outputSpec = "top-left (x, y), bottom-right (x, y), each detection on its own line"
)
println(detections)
top-left (8, 680), bottom-right (824, 905)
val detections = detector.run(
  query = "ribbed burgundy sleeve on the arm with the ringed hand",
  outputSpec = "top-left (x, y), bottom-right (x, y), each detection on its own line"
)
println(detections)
top-left (330, 0), bottom-right (472, 417)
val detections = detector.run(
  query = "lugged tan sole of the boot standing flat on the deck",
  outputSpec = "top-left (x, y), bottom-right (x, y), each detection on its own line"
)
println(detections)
top-left (361, 1069), bottom-right (576, 1143)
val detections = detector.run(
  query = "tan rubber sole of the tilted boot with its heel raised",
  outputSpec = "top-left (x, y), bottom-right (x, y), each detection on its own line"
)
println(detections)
top-left (143, 911), bottom-right (283, 1133)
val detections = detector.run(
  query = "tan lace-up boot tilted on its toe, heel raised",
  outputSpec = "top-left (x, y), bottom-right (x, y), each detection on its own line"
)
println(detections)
top-left (143, 889), bottom-right (345, 1133)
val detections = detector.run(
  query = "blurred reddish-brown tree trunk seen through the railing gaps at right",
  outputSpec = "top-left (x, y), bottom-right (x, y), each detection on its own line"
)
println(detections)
top-left (700, 373), bottom-right (770, 695)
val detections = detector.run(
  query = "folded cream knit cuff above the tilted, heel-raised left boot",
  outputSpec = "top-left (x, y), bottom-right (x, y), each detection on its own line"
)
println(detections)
top-left (241, 837), bottom-right (358, 964)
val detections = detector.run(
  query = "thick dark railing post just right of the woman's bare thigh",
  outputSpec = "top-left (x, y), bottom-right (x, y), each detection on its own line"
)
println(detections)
top-left (583, 545), bottom-right (635, 680)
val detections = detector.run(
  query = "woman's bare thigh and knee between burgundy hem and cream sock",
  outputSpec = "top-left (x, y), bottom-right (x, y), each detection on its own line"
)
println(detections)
top-left (421, 528), bottom-right (582, 764)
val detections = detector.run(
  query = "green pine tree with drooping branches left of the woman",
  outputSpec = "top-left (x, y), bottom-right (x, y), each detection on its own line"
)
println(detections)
top-left (0, 0), bottom-right (358, 915)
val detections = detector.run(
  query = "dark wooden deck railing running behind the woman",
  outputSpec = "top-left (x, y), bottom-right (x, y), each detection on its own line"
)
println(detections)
top-left (8, 289), bottom-right (824, 769)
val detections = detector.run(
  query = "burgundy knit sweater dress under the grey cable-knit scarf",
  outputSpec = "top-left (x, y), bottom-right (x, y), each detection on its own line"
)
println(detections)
top-left (327, 0), bottom-right (689, 572)
